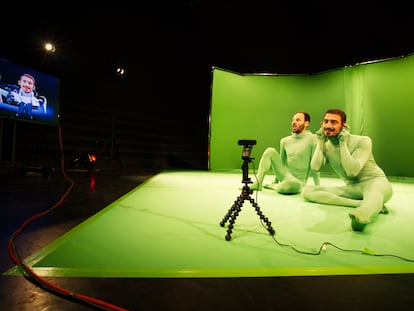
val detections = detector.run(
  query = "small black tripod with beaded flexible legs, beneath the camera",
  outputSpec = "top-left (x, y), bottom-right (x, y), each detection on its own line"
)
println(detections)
top-left (220, 151), bottom-right (275, 241)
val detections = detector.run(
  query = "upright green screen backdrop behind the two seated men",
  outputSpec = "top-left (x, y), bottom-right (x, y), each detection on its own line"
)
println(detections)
top-left (209, 55), bottom-right (414, 177)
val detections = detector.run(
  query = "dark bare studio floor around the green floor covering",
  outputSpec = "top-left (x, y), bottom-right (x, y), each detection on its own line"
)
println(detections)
top-left (0, 168), bottom-right (414, 311)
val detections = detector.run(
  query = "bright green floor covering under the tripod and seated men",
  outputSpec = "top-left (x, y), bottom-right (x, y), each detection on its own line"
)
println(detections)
top-left (5, 171), bottom-right (414, 278)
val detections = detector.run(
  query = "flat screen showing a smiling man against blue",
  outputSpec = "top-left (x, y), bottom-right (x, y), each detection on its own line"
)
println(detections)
top-left (0, 59), bottom-right (60, 125)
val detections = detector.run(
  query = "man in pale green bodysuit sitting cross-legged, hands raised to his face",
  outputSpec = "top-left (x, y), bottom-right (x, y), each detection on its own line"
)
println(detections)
top-left (302, 109), bottom-right (393, 231)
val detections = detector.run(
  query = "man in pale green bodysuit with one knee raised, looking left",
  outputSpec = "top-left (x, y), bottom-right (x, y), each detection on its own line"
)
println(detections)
top-left (250, 112), bottom-right (320, 194)
